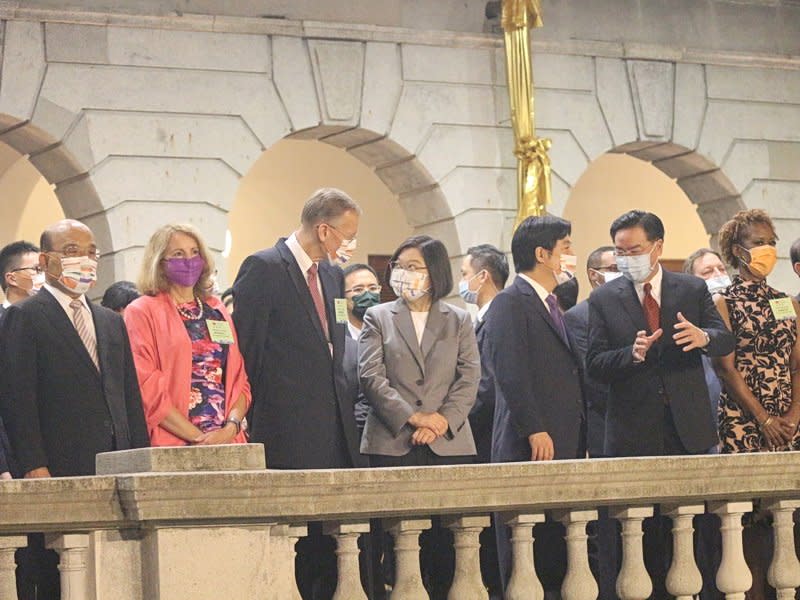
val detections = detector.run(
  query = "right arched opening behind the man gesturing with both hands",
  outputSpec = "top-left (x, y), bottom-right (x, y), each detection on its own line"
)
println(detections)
top-left (564, 142), bottom-right (744, 298)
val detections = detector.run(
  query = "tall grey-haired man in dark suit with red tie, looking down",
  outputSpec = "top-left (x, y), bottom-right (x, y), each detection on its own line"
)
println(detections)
top-left (233, 188), bottom-right (363, 600)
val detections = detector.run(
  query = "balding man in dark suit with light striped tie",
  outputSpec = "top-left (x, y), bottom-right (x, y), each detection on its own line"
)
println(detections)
top-left (0, 219), bottom-right (149, 598)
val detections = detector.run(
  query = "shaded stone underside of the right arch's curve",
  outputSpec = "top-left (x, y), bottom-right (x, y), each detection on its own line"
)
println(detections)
top-left (609, 141), bottom-right (746, 246)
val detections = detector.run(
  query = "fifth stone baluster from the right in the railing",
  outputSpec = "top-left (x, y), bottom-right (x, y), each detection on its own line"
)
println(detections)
top-left (553, 510), bottom-right (600, 600)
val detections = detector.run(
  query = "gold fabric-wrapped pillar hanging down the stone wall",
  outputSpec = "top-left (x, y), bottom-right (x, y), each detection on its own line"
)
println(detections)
top-left (502, 0), bottom-right (551, 227)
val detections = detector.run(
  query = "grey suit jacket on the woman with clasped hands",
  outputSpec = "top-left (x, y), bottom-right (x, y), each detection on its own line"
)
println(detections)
top-left (358, 300), bottom-right (481, 456)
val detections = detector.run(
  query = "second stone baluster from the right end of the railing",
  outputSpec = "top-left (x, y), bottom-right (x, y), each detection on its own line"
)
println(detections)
top-left (709, 502), bottom-right (753, 600)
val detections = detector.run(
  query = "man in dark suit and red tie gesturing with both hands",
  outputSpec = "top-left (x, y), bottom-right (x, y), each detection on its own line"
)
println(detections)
top-left (587, 210), bottom-right (735, 597)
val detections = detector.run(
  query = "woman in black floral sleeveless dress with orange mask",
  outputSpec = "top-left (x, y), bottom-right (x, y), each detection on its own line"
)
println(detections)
top-left (715, 209), bottom-right (800, 453)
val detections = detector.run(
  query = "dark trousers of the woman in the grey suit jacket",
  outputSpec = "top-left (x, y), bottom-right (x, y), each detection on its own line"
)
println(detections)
top-left (369, 446), bottom-right (475, 600)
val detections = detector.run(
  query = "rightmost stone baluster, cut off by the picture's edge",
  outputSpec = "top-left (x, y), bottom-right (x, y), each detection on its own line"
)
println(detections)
top-left (764, 500), bottom-right (800, 600)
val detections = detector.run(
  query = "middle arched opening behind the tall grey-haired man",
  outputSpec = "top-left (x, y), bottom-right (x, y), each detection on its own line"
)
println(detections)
top-left (228, 126), bottom-right (460, 285)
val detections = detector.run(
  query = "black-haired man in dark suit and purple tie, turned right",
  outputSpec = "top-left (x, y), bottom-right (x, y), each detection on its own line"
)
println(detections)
top-left (484, 216), bottom-right (585, 593)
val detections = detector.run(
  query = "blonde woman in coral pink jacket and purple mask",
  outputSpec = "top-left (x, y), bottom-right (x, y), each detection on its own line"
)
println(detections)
top-left (125, 225), bottom-right (251, 446)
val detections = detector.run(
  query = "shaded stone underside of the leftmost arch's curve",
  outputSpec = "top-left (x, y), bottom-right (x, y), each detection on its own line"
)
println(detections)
top-left (0, 114), bottom-right (114, 274)
